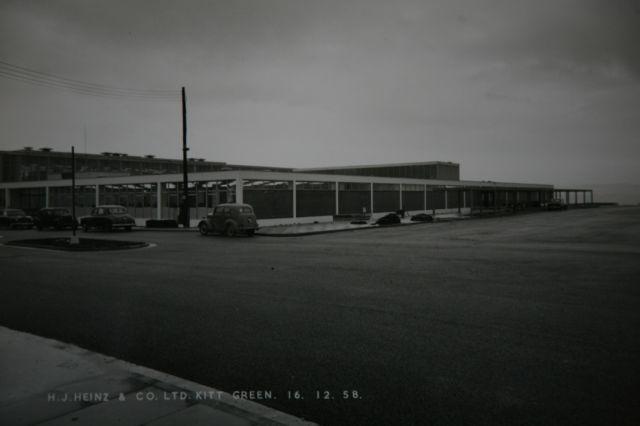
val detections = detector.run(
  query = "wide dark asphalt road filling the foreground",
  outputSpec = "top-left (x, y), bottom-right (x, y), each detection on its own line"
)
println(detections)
top-left (0, 207), bottom-right (640, 425)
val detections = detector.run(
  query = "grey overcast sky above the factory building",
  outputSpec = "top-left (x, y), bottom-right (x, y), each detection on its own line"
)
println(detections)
top-left (0, 0), bottom-right (640, 185)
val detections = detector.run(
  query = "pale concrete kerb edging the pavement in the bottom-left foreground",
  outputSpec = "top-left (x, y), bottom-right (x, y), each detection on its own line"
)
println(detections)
top-left (0, 326), bottom-right (316, 425)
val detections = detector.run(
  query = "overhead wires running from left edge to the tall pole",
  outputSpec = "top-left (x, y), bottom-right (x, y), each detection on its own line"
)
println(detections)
top-left (0, 61), bottom-right (180, 101)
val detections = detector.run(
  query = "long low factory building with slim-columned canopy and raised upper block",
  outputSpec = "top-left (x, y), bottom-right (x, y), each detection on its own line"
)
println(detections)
top-left (0, 149), bottom-right (593, 225)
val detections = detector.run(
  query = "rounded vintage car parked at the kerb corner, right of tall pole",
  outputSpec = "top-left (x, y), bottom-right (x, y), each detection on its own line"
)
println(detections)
top-left (198, 203), bottom-right (258, 237)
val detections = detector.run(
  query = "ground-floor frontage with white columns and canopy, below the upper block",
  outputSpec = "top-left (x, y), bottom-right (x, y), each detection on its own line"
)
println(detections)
top-left (0, 170), bottom-right (553, 224)
